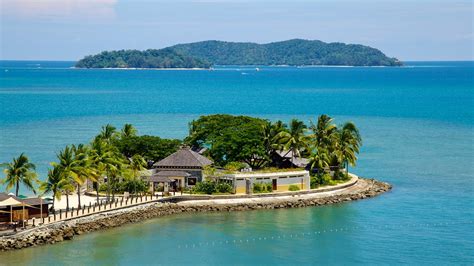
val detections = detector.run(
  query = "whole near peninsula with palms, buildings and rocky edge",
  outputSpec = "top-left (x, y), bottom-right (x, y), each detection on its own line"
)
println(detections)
top-left (0, 114), bottom-right (391, 251)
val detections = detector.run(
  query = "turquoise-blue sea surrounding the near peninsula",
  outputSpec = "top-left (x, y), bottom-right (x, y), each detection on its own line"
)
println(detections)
top-left (0, 61), bottom-right (474, 265)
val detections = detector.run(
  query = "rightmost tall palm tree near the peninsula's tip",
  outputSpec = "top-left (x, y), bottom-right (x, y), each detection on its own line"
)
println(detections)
top-left (338, 122), bottom-right (362, 176)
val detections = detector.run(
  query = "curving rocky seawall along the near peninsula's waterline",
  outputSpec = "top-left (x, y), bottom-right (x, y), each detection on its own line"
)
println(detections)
top-left (0, 178), bottom-right (392, 251)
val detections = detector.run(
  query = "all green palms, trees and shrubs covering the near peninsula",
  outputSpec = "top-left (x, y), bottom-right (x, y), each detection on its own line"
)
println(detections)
top-left (1, 114), bottom-right (362, 203)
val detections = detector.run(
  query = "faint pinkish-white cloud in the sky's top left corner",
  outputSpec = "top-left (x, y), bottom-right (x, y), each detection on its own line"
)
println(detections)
top-left (0, 0), bottom-right (117, 19)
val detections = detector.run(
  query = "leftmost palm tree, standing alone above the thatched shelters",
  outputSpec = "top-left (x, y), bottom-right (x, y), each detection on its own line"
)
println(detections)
top-left (0, 153), bottom-right (38, 196)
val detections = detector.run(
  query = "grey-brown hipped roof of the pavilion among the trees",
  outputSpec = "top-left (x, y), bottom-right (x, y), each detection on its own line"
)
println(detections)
top-left (153, 148), bottom-right (213, 167)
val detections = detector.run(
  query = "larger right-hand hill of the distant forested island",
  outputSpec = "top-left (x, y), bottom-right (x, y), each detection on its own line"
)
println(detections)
top-left (171, 39), bottom-right (401, 66)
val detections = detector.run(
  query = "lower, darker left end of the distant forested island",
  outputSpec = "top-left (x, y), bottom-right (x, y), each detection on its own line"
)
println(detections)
top-left (76, 48), bottom-right (211, 68)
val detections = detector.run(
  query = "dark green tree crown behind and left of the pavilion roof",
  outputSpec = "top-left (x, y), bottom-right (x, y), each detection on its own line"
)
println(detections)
top-left (113, 135), bottom-right (181, 162)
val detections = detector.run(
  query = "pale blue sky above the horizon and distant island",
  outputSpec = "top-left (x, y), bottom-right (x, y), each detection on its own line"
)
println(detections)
top-left (0, 0), bottom-right (474, 61)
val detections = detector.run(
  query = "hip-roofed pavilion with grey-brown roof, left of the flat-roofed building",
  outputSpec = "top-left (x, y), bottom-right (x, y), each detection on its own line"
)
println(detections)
top-left (148, 147), bottom-right (213, 190)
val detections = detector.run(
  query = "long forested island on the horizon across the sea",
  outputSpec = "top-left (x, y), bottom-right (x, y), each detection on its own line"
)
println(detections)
top-left (76, 39), bottom-right (402, 68)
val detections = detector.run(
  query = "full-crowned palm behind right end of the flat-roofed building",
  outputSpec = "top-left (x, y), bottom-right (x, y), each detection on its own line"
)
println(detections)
top-left (278, 119), bottom-right (308, 166)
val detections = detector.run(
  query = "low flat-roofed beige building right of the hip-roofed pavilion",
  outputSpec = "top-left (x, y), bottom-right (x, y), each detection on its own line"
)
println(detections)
top-left (220, 170), bottom-right (310, 194)
